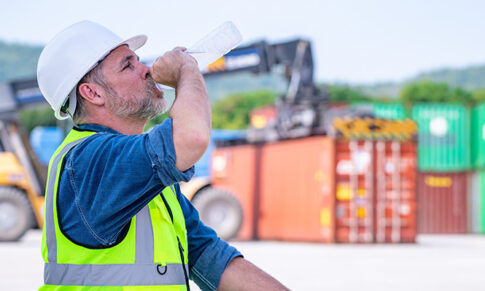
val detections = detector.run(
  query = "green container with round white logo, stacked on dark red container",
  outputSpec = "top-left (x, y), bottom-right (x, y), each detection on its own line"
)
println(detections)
top-left (412, 103), bottom-right (471, 172)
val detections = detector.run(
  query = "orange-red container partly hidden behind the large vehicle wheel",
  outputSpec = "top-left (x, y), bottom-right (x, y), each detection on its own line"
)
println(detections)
top-left (211, 145), bottom-right (259, 240)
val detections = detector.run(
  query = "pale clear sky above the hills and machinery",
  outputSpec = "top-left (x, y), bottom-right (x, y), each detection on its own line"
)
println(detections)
top-left (0, 0), bottom-right (485, 84)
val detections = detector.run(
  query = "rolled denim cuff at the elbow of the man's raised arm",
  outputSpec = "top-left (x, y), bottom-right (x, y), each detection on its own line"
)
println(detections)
top-left (145, 118), bottom-right (194, 185)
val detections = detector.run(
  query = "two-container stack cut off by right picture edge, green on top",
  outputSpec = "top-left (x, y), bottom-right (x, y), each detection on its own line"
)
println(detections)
top-left (468, 103), bottom-right (485, 233)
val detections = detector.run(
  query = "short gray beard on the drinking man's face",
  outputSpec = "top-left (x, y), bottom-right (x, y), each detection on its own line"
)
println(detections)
top-left (107, 76), bottom-right (167, 120)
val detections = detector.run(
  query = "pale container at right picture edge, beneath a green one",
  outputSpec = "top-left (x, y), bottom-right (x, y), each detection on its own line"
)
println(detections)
top-left (468, 170), bottom-right (485, 233)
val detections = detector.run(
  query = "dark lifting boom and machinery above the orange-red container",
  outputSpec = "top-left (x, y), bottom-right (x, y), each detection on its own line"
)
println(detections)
top-left (203, 39), bottom-right (329, 143)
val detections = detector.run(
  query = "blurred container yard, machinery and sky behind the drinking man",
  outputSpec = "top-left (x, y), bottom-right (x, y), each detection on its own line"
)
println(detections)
top-left (0, 0), bottom-right (485, 290)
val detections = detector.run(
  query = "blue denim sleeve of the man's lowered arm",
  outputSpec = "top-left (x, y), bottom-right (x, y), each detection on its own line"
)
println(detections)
top-left (176, 185), bottom-right (242, 290)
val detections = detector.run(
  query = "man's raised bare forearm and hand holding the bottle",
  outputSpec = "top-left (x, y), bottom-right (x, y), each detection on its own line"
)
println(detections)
top-left (150, 48), bottom-right (211, 171)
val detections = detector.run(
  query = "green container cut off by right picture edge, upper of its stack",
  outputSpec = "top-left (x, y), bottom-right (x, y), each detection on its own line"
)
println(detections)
top-left (471, 103), bottom-right (485, 169)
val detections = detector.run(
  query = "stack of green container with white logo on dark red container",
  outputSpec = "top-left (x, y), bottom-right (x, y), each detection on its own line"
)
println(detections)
top-left (411, 103), bottom-right (471, 233)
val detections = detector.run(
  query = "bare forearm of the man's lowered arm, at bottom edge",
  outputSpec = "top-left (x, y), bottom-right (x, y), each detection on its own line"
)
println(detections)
top-left (217, 257), bottom-right (289, 291)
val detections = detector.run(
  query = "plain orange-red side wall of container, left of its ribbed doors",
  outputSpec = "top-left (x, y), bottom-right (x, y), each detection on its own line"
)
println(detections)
top-left (258, 137), bottom-right (335, 242)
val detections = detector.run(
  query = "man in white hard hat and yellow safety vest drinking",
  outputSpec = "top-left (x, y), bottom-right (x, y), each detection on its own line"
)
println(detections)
top-left (37, 21), bottom-right (286, 290)
